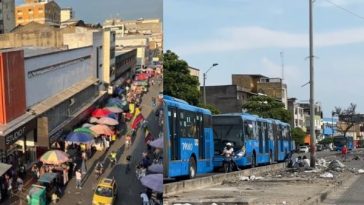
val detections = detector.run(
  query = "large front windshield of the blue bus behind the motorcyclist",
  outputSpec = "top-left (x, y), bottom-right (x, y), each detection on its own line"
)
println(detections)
top-left (214, 125), bottom-right (244, 152)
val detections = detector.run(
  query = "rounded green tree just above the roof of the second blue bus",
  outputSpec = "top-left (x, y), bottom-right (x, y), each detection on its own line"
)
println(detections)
top-left (243, 95), bottom-right (291, 123)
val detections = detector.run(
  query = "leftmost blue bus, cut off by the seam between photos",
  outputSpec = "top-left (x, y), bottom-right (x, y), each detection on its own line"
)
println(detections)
top-left (163, 96), bottom-right (214, 178)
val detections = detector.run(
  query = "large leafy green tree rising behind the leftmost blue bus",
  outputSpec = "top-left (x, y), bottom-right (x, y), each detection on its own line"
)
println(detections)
top-left (163, 50), bottom-right (200, 105)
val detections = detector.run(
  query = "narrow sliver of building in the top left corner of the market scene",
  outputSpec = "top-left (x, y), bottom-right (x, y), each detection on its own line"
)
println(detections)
top-left (0, 0), bottom-right (15, 34)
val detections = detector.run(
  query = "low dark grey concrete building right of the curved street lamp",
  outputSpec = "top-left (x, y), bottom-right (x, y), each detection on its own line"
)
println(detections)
top-left (200, 85), bottom-right (256, 113)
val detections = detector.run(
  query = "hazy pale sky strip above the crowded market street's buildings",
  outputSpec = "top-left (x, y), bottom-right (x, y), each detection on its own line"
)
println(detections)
top-left (15, 0), bottom-right (163, 23)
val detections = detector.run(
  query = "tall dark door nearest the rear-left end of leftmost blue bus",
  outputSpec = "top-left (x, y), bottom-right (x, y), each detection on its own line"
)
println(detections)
top-left (168, 107), bottom-right (181, 161)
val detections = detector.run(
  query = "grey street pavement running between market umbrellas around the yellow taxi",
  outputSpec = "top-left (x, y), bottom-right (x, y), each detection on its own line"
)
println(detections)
top-left (59, 79), bottom-right (162, 205)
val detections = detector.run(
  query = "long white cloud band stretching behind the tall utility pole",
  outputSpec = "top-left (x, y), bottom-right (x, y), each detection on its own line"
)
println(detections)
top-left (172, 27), bottom-right (364, 55)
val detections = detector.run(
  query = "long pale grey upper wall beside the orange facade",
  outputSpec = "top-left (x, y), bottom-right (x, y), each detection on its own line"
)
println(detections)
top-left (25, 47), bottom-right (95, 107)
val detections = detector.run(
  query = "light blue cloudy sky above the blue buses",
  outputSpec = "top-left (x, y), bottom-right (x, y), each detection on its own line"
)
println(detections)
top-left (163, 0), bottom-right (364, 116)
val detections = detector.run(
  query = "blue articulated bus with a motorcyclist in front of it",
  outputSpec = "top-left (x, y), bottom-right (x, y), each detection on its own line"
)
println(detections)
top-left (212, 113), bottom-right (293, 168)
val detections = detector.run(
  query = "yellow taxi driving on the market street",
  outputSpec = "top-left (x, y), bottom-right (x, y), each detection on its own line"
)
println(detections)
top-left (92, 178), bottom-right (118, 205)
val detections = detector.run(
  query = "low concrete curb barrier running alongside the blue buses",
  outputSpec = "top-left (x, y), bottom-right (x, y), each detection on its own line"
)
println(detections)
top-left (163, 163), bottom-right (286, 196)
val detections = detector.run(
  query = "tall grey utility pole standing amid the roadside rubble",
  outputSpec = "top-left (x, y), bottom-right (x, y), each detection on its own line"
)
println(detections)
top-left (308, 0), bottom-right (316, 167)
